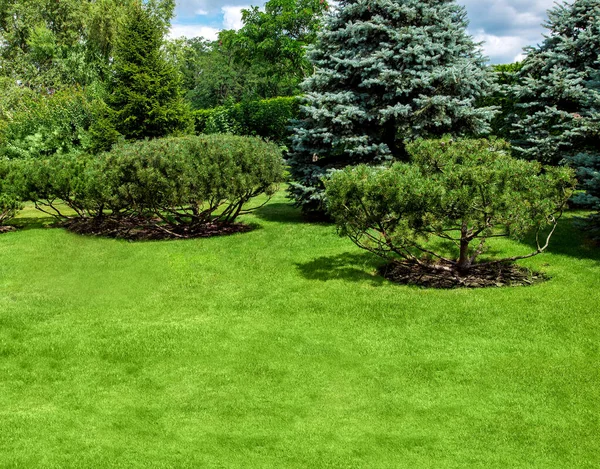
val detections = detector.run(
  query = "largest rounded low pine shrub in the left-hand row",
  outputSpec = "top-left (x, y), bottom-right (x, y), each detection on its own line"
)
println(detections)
top-left (93, 135), bottom-right (283, 225)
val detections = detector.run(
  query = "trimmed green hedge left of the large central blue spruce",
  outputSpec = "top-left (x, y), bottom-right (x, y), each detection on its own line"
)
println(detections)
top-left (194, 97), bottom-right (300, 144)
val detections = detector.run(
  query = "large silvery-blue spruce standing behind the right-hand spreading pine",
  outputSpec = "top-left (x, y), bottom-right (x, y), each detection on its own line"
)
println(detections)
top-left (290, 0), bottom-right (494, 211)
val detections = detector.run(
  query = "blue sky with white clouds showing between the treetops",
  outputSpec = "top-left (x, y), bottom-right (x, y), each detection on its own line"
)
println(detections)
top-left (171, 0), bottom-right (554, 63)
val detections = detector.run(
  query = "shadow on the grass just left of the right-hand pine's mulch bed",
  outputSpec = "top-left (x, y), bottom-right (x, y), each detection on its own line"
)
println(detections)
top-left (296, 252), bottom-right (386, 285)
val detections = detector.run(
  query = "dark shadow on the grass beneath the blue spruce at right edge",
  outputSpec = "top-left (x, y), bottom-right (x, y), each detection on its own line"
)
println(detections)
top-left (523, 214), bottom-right (600, 262)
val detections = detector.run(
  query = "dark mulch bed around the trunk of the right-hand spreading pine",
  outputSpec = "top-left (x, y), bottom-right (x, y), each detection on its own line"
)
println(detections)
top-left (379, 263), bottom-right (548, 288)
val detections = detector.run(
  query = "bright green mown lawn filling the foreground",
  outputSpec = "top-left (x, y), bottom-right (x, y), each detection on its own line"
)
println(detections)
top-left (0, 195), bottom-right (600, 469)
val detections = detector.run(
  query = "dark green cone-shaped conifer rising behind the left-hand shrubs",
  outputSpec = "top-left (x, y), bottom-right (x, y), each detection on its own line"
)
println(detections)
top-left (107, 3), bottom-right (190, 140)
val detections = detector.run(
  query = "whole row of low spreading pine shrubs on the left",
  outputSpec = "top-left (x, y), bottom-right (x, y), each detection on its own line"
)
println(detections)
top-left (5, 135), bottom-right (283, 232)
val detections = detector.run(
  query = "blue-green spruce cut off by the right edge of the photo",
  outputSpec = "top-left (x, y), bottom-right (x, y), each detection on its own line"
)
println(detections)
top-left (512, 0), bottom-right (600, 237)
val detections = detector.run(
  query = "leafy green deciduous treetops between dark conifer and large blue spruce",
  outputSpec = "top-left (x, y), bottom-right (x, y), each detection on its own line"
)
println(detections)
top-left (167, 0), bottom-right (328, 109)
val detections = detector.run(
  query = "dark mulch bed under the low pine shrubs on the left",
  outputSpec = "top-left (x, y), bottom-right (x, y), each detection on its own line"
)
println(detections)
top-left (63, 218), bottom-right (252, 241)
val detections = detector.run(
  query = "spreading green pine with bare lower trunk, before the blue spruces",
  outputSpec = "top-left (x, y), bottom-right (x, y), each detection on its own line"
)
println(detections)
top-left (326, 138), bottom-right (575, 274)
